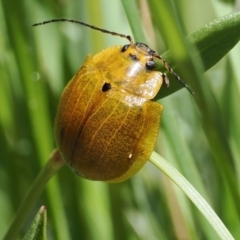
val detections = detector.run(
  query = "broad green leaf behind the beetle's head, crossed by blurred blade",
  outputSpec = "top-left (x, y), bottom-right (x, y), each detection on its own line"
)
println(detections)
top-left (156, 12), bottom-right (240, 99)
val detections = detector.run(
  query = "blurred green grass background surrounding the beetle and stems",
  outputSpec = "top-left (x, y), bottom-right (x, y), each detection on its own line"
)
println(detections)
top-left (0, 0), bottom-right (240, 240)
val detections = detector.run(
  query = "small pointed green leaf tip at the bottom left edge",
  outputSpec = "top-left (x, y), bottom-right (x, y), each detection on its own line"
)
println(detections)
top-left (23, 206), bottom-right (47, 240)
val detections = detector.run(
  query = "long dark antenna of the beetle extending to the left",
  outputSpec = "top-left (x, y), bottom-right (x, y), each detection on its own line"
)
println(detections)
top-left (32, 18), bottom-right (133, 44)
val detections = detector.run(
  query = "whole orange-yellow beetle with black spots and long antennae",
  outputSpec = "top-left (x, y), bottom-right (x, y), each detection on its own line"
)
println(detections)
top-left (33, 19), bottom-right (190, 183)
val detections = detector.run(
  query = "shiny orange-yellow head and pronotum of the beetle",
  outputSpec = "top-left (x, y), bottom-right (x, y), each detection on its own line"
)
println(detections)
top-left (93, 43), bottom-right (163, 99)
